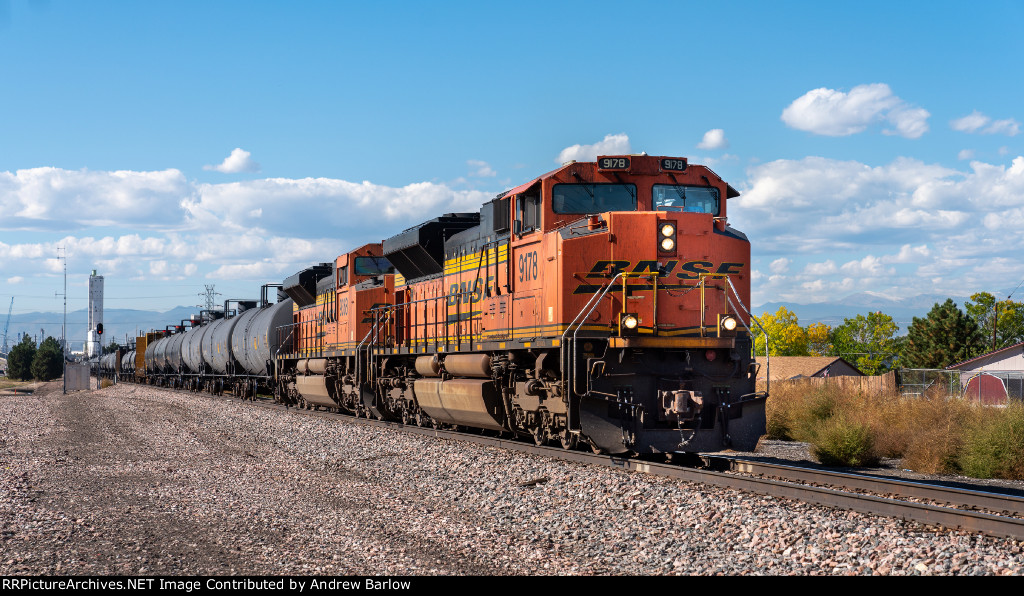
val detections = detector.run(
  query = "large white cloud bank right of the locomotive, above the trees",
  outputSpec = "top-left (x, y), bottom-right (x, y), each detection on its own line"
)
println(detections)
top-left (728, 157), bottom-right (1024, 304)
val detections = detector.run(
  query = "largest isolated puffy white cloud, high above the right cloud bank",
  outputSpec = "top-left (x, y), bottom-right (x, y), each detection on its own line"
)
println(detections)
top-left (782, 83), bottom-right (931, 138)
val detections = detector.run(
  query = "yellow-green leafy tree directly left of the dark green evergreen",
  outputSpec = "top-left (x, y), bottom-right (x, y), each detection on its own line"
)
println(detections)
top-left (833, 312), bottom-right (900, 375)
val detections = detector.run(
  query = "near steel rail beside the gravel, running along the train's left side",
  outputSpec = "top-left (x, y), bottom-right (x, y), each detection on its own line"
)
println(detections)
top-left (144, 389), bottom-right (1024, 541)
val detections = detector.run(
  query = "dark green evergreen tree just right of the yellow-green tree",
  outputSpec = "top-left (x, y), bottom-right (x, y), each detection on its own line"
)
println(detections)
top-left (901, 298), bottom-right (984, 369)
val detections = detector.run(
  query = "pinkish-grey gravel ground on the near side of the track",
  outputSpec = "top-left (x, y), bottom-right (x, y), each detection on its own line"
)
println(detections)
top-left (0, 382), bottom-right (1024, 576)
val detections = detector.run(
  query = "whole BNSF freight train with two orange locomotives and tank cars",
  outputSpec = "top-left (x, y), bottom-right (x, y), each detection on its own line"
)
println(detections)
top-left (105, 155), bottom-right (767, 454)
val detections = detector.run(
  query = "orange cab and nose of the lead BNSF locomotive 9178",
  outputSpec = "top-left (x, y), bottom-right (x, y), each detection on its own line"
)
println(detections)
top-left (483, 156), bottom-right (765, 453)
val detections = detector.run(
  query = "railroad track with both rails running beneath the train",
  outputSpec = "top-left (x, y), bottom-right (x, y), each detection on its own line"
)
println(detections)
top-left (140, 389), bottom-right (1024, 541)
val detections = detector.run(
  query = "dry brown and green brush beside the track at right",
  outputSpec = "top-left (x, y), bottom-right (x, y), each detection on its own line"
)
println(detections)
top-left (767, 382), bottom-right (1024, 479)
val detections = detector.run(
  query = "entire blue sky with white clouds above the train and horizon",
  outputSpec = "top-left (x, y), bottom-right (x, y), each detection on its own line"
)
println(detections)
top-left (0, 0), bottom-right (1024, 321)
